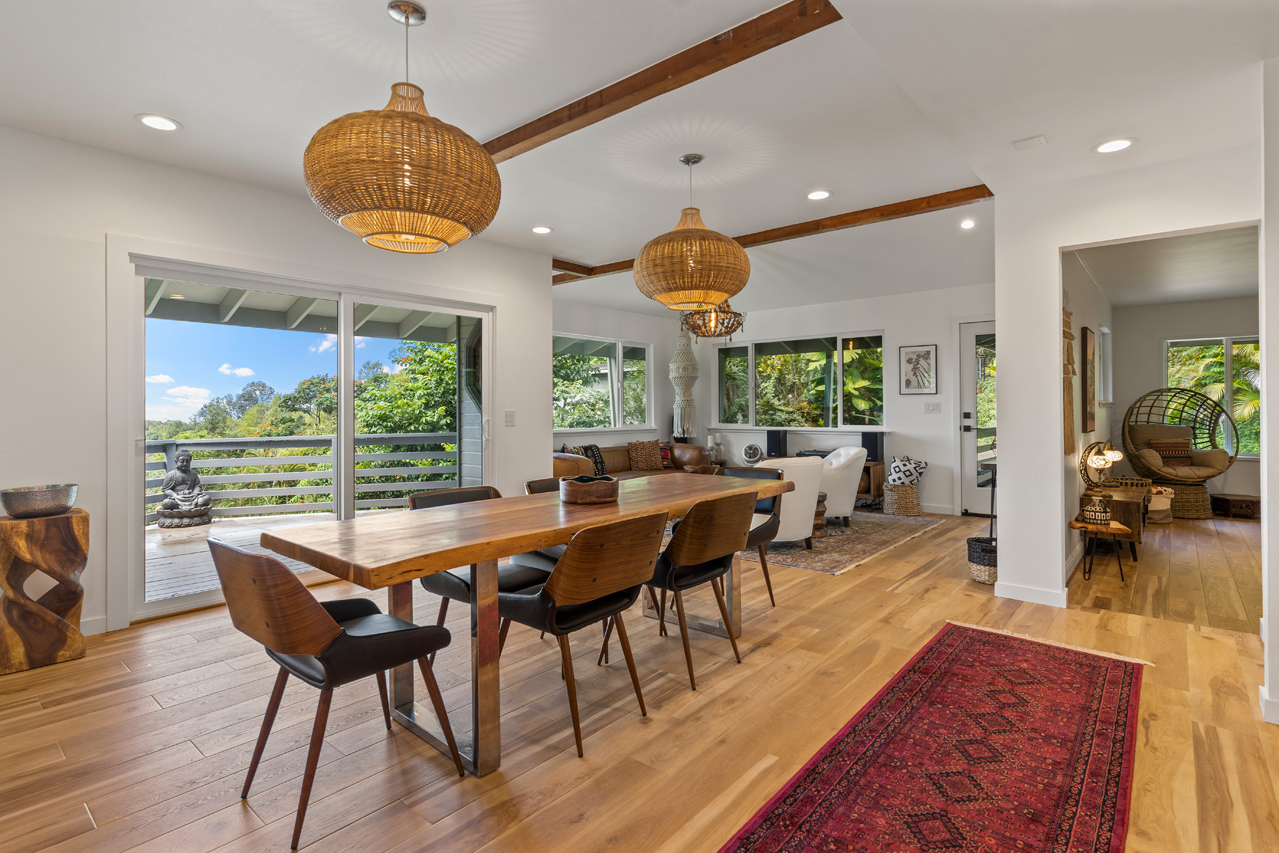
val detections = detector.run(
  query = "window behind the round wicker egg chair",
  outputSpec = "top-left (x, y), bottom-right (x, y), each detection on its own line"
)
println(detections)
top-left (1166, 338), bottom-right (1261, 455)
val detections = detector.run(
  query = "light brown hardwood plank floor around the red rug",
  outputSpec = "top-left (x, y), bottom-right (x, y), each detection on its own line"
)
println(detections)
top-left (0, 518), bottom-right (1279, 853)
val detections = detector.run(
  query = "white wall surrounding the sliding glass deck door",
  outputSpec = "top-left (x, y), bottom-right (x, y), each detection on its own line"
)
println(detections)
top-left (0, 128), bottom-right (551, 632)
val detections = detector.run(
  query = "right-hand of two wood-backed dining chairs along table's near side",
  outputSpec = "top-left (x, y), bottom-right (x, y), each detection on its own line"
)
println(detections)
top-left (648, 492), bottom-right (756, 691)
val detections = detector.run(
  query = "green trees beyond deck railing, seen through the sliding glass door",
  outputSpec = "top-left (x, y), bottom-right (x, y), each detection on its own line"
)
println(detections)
top-left (146, 341), bottom-right (458, 521)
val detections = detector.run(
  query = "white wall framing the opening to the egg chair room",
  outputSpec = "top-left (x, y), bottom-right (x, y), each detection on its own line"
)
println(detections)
top-left (995, 147), bottom-right (1261, 606)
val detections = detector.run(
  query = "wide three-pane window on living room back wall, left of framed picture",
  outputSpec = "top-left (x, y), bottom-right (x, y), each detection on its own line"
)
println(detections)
top-left (718, 335), bottom-right (884, 428)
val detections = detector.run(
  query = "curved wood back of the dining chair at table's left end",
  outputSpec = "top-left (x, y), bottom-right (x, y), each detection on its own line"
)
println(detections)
top-left (208, 538), bottom-right (341, 655)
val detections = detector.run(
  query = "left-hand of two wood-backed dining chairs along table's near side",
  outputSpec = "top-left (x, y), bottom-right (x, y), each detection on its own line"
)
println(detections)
top-left (498, 513), bottom-right (666, 757)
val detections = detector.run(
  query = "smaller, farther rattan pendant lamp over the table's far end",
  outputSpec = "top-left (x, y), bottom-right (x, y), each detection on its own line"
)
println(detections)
top-left (634, 153), bottom-right (751, 311)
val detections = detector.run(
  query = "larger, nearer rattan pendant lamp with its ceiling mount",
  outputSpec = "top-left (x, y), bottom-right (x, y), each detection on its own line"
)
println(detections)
top-left (302, 0), bottom-right (501, 254)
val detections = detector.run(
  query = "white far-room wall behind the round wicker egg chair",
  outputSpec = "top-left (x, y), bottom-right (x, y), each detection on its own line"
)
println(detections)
top-left (1111, 297), bottom-right (1261, 495)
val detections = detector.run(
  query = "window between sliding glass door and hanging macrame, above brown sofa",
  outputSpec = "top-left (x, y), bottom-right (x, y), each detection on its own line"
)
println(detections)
top-left (551, 335), bottom-right (648, 430)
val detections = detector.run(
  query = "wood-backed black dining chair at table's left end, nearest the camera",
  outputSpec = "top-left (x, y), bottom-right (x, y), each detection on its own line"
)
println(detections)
top-left (208, 538), bottom-right (466, 849)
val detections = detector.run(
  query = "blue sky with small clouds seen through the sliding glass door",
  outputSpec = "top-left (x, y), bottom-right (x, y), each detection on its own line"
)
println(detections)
top-left (146, 317), bottom-right (400, 421)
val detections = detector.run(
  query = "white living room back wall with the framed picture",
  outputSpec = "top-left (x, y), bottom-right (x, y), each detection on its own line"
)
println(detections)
top-left (696, 284), bottom-right (995, 514)
